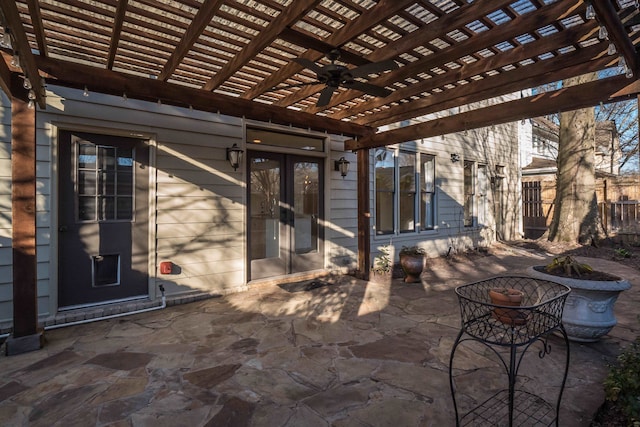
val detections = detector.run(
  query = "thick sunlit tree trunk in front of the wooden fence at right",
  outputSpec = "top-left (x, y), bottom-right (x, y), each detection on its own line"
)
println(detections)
top-left (548, 73), bottom-right (602, 244)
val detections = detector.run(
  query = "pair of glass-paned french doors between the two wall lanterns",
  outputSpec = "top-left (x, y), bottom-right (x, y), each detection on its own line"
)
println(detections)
top-left (247, 152), bottom-right (324, 280)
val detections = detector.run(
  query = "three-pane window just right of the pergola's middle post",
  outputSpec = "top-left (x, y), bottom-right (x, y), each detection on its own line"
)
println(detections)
top-left (374, 148), bottom-right (436, 235)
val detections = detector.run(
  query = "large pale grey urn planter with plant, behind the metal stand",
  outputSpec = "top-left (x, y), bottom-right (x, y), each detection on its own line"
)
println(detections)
top-left (528, 256), bottom-right (631, 342)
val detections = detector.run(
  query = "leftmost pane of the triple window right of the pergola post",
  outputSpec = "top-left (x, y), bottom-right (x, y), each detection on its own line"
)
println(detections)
top-left (374, 148), bottom-right (395, 234)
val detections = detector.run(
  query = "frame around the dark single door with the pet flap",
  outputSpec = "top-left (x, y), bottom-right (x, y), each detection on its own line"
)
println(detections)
top-left (48, 123), bottom-right (158, 315)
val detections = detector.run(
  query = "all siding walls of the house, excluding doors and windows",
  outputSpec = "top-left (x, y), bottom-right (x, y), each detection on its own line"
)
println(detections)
top-left (0, 85), bottom-right (520, 326)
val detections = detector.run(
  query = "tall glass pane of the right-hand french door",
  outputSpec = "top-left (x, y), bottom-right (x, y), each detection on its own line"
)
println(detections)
top-left (293, 162), bottom-right (320, 254)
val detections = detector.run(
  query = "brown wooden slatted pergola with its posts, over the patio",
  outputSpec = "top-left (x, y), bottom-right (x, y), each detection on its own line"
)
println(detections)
top-left (0, 0), bottom-right (640, 348)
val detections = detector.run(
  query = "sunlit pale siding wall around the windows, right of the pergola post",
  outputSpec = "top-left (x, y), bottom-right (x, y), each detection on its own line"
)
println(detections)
top-left (370, 123), bottom-right (520, 263)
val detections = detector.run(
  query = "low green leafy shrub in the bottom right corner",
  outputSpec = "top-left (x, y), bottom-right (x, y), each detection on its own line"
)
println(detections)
top-left (604, 337), bottom-right (640, 426)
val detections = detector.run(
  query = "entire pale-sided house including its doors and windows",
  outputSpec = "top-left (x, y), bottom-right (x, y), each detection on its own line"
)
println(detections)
top-left (0, 84), bottom-right (521, 332)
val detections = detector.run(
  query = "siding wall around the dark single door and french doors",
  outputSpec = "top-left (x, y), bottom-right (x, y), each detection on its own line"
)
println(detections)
top-left (0, 85), bottom-right (357, 325)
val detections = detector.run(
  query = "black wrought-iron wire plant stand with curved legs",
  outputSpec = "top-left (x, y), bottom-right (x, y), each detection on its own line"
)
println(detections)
top-left (449, 276), bottom-right (571, 427)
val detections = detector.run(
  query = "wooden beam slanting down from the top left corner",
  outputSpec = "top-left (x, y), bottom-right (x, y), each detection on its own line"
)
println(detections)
top-left (0, 1), bottom-right (46, 109)
